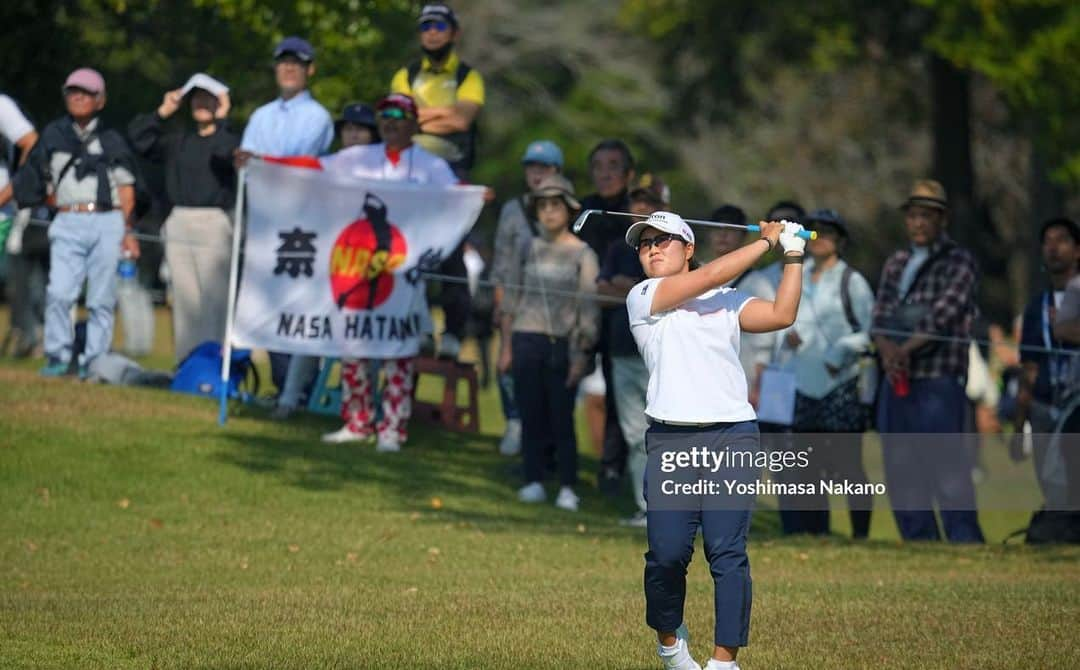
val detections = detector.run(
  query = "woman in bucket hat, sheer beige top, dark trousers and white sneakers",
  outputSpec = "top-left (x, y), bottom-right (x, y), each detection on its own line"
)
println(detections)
top-left (499, 174), bottom-right (599, 511)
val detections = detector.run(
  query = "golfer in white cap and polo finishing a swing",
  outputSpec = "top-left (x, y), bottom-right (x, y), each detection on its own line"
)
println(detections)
top-left (626, 212), bottom-right (806, 670)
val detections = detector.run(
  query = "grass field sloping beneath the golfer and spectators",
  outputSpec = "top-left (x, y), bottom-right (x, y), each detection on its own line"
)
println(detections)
top-left (0, 306), bottom-right (1080, 670)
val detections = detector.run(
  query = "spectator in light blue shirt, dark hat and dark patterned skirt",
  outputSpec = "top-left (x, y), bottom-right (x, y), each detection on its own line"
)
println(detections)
top-left (778, 209), bottom-right (876, 539)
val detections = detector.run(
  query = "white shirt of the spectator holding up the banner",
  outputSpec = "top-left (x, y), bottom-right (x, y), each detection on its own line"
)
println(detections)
top-left (320, 143), bottom-right (460, 186)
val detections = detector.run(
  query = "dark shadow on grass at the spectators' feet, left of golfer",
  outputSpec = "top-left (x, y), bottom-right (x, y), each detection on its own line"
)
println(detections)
top-left (215, 410), bottom-right (807, 542)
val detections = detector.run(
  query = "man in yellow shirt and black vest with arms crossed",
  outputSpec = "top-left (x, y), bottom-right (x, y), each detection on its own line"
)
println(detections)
top-left (390, 4), bottom-right (484, 179)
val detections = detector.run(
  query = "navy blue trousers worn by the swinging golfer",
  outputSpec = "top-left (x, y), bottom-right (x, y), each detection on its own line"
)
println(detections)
top-left (645, 421), bottom-right (759, 646)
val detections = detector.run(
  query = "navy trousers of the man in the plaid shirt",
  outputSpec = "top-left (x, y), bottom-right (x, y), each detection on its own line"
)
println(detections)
top-left (877, 377), bottom-right (985, 542)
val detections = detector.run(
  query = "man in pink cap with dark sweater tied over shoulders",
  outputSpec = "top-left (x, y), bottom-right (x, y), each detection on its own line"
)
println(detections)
top-left (14, 68), bottom-right (139, 377)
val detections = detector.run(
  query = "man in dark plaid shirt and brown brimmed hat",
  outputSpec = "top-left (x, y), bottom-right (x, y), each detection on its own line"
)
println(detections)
top-left (874, 179), bottom-right (984, 542)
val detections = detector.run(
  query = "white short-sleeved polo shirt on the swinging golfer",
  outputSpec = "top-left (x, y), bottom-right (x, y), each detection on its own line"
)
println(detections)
top-left (626, 278), bottom-right (757, 424)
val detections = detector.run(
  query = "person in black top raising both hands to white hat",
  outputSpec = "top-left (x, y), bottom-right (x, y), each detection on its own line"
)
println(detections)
top-left (127, 72), bottom-right (240, 361)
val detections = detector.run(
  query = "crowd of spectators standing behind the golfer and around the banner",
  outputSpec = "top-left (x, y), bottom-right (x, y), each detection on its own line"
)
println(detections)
top-left (0, 4), bottom-right (1080, 541)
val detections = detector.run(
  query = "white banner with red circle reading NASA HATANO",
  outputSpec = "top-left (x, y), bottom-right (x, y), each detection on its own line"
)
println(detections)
top-left (232, 161), bottom-right (484, 358)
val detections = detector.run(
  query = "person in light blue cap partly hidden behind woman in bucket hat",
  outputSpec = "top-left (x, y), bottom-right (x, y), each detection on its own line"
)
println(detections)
top-left (491, 139), bottom-right (563, 456)
